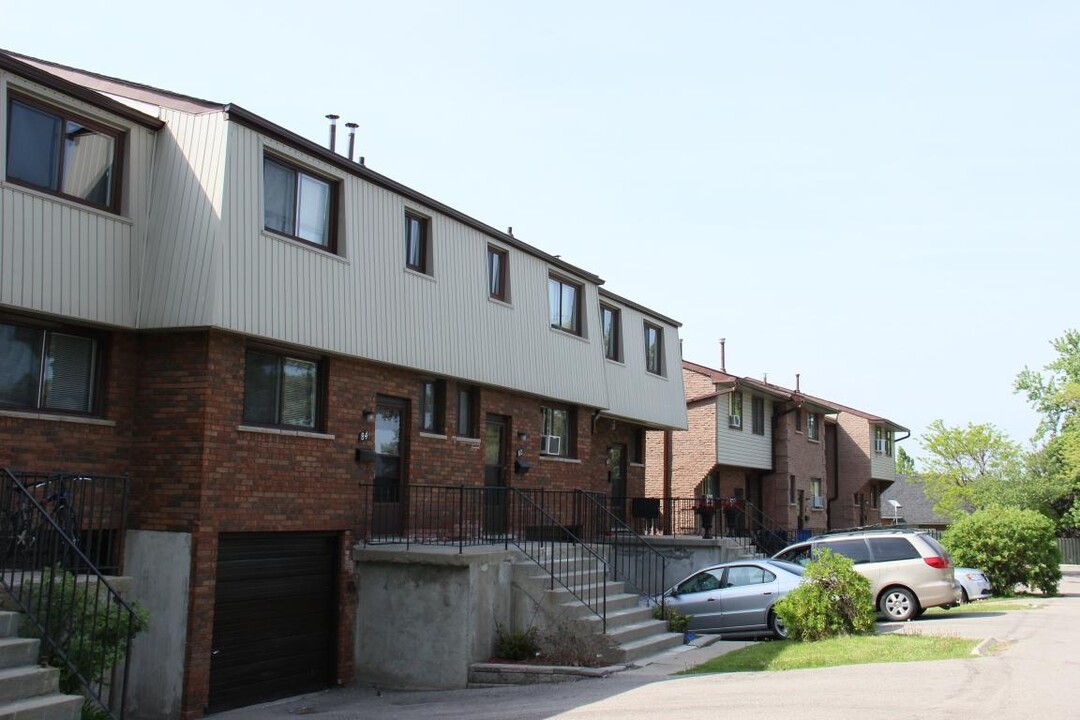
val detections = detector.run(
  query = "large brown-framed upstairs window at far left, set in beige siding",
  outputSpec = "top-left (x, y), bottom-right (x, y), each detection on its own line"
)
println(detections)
top-left (8, 95), bottom-right (122, 213)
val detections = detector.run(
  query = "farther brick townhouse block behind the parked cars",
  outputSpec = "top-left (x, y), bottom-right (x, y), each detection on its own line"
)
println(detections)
top-left (646, 362), bottom-right (905, 536)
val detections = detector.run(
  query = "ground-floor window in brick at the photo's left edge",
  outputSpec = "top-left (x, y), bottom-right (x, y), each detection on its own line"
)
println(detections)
top-left (0, 323), bottom-right (100, 413)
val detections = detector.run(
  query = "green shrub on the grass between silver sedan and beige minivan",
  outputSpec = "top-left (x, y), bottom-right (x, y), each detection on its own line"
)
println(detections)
top-left (773, 548), bottom-right (875, 641)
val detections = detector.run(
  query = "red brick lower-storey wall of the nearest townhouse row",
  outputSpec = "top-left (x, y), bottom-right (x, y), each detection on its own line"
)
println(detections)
top-left (6, 331), bottom-right (646, 718)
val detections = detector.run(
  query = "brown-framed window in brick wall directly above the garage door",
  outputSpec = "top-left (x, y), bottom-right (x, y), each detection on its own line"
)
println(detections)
top-left (244, 350), bottom-right (323, 430)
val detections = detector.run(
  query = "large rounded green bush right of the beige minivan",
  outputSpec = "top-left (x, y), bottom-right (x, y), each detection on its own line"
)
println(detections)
top-left (942, 507), bottom-right (1062, 596)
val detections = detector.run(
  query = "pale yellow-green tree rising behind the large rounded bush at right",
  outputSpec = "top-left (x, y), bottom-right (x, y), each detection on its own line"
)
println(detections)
top-left (916, 420), bottom-right (1025, 517)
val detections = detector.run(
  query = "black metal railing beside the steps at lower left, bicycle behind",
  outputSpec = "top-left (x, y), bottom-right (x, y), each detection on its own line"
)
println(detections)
top-left (0, 468), bottom-right (143, 719)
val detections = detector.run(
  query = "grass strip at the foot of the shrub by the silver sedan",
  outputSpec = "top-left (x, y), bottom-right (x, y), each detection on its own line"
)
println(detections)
top-left (679, 635), bottom-right (981, 675)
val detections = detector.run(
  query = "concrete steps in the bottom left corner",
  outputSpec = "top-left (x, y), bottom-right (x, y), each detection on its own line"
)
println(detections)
top-left (0, 611), bottom-right (82, 720)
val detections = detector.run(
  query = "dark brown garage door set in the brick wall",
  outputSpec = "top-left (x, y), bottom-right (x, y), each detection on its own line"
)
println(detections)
top-left (208, 532), bottom-right (338, 712)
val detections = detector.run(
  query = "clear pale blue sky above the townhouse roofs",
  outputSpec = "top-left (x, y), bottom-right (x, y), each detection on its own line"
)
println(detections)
top-left (0, 0), bottom-right (1080, 456)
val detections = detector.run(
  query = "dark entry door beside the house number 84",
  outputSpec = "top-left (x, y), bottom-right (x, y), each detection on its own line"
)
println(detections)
top-left (372, 396), bottom-right (408, 535)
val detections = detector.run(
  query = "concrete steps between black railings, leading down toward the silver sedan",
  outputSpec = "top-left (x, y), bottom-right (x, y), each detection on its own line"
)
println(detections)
top-left (514, 556), bottom-right (683, 664)
